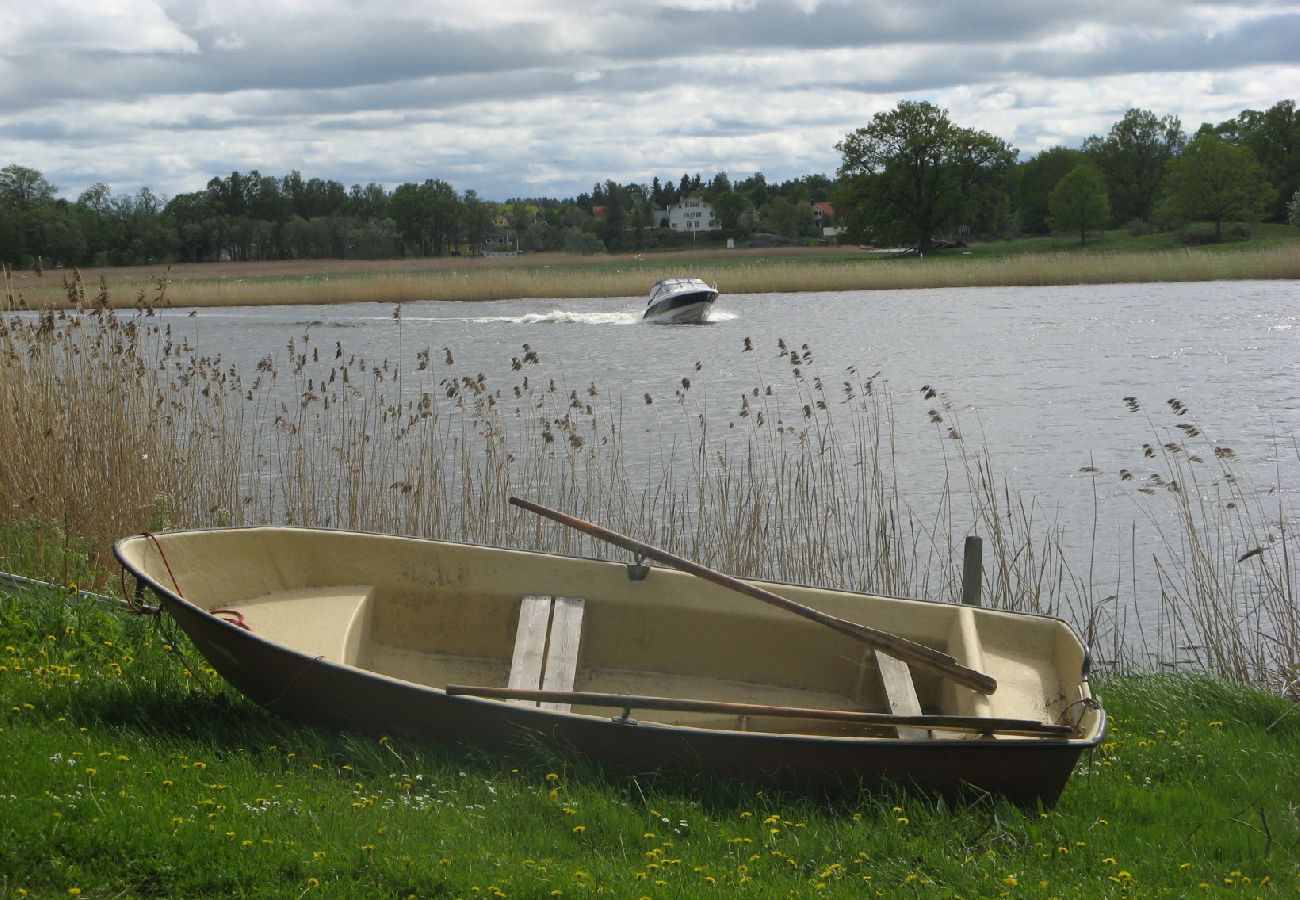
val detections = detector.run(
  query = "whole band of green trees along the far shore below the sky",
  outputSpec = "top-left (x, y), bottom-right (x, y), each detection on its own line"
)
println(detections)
top-left (0, 100), bottom-right (1300, 268)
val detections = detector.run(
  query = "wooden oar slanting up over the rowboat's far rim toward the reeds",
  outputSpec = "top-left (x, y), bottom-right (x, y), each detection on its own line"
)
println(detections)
top-left (510, 497), bottom-right (997, 693)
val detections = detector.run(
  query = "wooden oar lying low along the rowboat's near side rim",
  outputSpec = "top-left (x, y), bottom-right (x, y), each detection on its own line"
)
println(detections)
top-left (447, 684), bottom-right (1074, 737)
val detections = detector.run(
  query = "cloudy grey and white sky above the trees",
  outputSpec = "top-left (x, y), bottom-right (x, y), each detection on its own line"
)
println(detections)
top-left (0, 0), bottom-right (1300, 200)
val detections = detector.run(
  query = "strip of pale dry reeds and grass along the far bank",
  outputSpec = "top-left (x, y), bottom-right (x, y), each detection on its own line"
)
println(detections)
top-left (0, 225), bottom-right (1300, 308)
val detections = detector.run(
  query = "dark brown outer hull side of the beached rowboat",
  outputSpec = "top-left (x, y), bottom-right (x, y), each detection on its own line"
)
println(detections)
top-left (117, 529), bottom-right (1105, 802)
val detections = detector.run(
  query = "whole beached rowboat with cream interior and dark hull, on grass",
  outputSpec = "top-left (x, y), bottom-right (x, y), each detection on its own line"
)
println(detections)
top-left (114, 498), bottom-right (1105, 802)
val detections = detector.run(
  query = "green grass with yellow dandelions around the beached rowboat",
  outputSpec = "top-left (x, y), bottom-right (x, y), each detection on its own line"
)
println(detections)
top-left (0, 588), bottom-right (1300, 897)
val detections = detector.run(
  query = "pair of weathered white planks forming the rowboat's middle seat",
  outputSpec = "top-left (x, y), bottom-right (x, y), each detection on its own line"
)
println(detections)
top-left (510, 594), bottom-right (585, 713)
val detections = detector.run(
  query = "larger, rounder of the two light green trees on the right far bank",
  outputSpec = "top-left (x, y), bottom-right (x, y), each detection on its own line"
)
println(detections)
top-left (1166, 131), bottom-right (1274, 241)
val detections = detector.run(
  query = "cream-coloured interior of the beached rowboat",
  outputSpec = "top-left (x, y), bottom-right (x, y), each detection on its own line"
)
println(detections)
top-left (118, 528), bottom-right (1099, 740)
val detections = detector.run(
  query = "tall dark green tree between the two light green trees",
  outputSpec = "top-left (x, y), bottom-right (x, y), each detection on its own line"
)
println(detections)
top-left (1083, 109), bottom-right (1187, 222)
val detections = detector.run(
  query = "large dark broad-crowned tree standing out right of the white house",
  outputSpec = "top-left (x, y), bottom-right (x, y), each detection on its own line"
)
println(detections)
top-left (836, 100), bottom-right (1015, 252)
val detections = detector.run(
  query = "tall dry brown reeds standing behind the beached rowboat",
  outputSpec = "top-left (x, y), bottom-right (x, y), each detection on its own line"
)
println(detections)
top-left (0, 281), bottom-right (1300, 692)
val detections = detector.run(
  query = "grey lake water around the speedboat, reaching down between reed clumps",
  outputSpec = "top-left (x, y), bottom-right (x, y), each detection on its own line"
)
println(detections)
top-left (144, 281), bottom-right (1300, 650)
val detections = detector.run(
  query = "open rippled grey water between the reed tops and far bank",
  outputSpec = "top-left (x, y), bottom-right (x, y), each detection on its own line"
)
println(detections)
top-left (185, 281), bottom-right (1300, 497)
